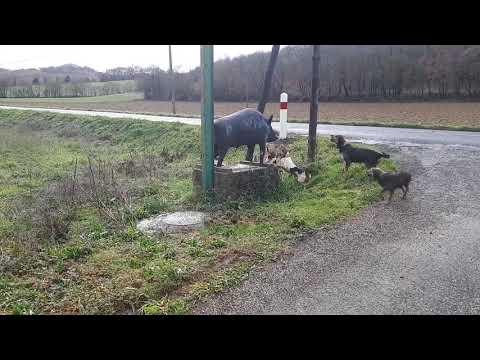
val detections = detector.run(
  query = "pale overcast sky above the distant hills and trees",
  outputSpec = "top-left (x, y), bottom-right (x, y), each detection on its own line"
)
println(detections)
top-left (0, 45), bottom-right (284, 72)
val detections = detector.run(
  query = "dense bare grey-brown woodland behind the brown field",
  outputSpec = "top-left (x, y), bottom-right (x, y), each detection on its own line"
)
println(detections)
top-left (140, 45), bottom-right (480, 103)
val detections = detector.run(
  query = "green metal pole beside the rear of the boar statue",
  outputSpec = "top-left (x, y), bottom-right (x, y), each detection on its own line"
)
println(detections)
top-left (200, 45), bottom-right (214, 194)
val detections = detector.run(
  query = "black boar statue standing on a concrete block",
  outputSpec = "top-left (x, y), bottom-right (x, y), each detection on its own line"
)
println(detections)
top-left (214, 109), bottom-right (279, 167)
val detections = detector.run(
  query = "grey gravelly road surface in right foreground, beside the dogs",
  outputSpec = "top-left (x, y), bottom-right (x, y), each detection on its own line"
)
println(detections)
top-left (194, 145), bottom-right (480, 314)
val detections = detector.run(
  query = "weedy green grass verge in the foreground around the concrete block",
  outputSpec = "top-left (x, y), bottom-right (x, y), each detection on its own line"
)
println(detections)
top-left (0, 110), bottom-right (394, 314)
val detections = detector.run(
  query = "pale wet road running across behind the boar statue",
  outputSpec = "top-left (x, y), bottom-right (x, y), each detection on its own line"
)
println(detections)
top-left (0, 106), bottom-right (480, 147)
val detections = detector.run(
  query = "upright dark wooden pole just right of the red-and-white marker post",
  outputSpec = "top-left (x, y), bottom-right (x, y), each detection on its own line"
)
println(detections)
top-left (308, 45), bottom-right (320, 162)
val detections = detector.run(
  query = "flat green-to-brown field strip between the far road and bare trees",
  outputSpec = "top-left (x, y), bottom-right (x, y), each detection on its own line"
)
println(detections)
top-left (0, 93), bottom-right (480, 128)
